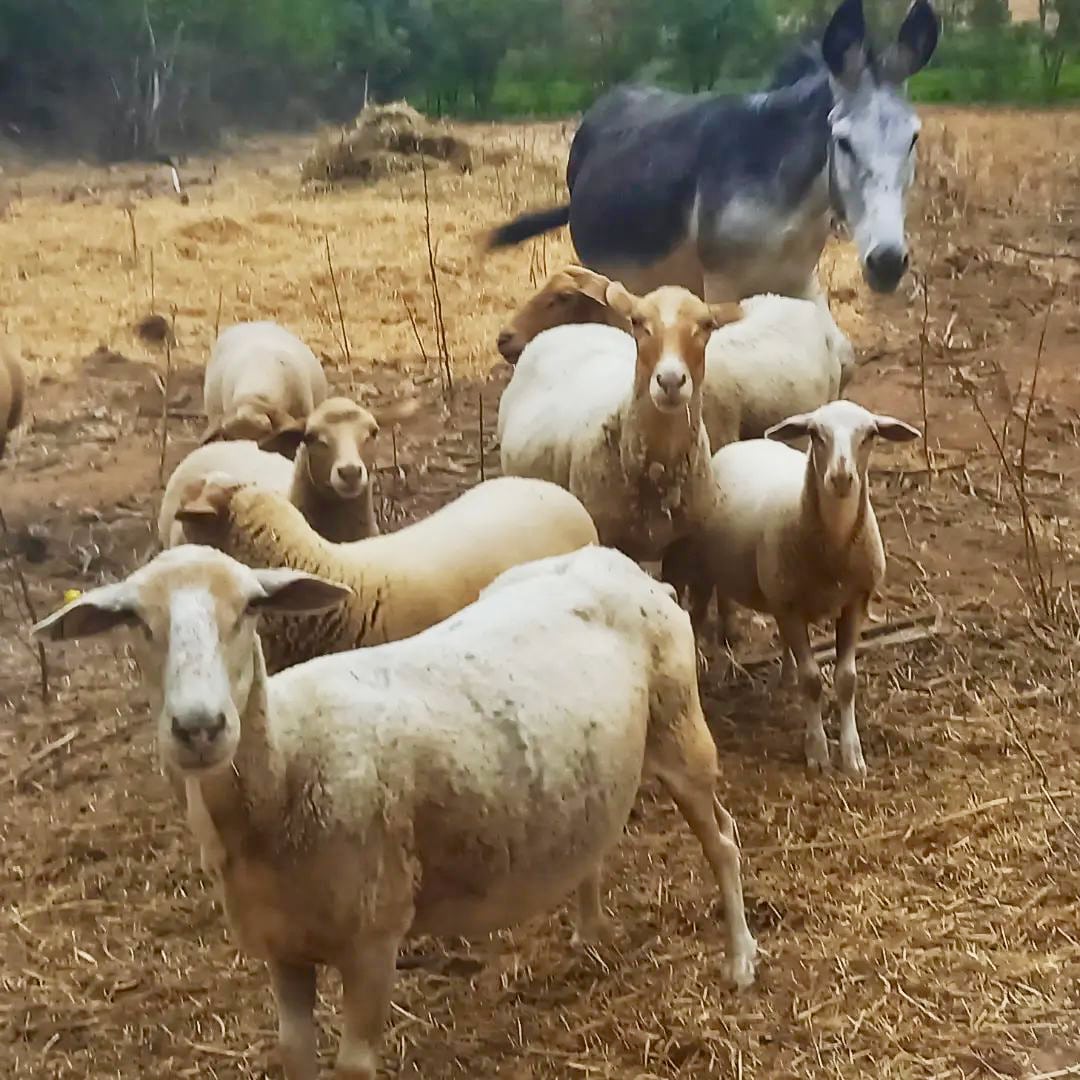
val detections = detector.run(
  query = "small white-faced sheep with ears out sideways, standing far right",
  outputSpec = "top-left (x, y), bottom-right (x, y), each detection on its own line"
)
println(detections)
top-left (663, 400), bottom-right (920, 775)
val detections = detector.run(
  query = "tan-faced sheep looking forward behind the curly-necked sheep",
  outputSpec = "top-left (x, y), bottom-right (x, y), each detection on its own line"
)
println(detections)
top-left (158, 397), bottom-right (399, 548)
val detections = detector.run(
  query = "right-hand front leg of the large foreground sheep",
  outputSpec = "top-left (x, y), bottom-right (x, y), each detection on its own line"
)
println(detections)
top-left (335, 936), bottom-right (399, 1080)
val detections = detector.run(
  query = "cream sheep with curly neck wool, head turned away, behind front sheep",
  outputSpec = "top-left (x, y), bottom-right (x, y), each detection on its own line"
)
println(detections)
top-left (177, 476), bottom-right (597, 672)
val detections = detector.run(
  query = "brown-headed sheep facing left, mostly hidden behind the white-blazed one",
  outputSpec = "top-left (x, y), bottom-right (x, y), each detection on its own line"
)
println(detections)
top-left (498, 272), bottom-right (854, 450)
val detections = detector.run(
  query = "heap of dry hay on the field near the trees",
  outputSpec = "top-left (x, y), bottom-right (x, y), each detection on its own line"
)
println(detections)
top-left (300, 102), bottom-right (473, 184)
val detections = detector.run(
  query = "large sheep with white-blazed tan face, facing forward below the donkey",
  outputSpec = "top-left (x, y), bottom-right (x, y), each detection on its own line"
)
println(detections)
top-left (498, 279), bottom-right (739, 562)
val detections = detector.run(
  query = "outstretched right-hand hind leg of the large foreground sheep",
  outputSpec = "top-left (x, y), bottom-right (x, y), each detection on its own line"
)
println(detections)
top-left (649, 705), bottom-right (757, 989)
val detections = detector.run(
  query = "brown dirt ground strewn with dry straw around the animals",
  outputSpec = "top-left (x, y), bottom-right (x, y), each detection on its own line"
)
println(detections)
top-left (0, 111), bottom-right (1080, 1080)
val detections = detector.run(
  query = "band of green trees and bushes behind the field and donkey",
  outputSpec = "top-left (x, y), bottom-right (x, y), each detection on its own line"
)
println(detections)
top-left (0, 0), bottom-right (1080, 158)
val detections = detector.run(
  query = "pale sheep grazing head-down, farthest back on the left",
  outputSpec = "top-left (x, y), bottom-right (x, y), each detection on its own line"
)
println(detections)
top-left (203, 322), bottom-right (328, 443)
